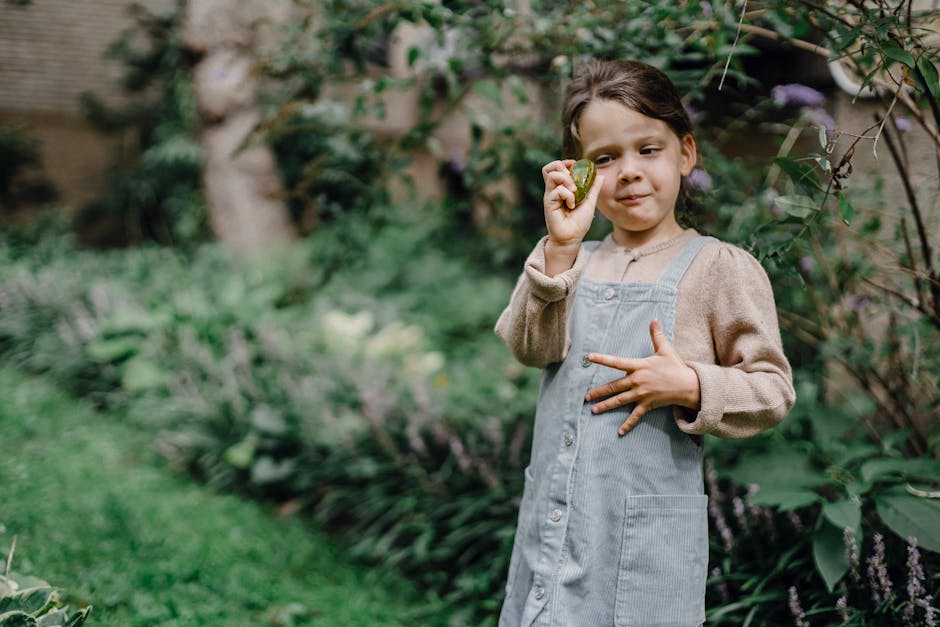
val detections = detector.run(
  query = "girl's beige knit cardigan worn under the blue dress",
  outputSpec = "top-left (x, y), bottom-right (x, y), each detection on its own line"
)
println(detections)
top-left (496, 229), bottom-right (796, 438)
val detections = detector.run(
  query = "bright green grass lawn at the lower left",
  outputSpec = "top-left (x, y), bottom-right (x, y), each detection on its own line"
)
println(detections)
top-left (0, 367), bottom-right (443, 627)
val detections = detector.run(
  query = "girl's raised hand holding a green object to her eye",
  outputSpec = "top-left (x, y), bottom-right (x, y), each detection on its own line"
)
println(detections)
top-left (542, 159), bottom-right (604, 249)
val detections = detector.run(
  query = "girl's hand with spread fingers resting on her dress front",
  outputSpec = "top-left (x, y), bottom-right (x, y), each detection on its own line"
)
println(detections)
top-left (584, 320), bottom-right (701, 436)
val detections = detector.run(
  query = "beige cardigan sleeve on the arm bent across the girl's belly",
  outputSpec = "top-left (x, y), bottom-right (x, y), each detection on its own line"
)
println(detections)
top-left (677, 244), bottom-right (796, 438)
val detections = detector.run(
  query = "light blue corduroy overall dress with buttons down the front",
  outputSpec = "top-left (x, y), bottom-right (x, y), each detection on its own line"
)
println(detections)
top-left (499, 237), bottom-right (715, 627)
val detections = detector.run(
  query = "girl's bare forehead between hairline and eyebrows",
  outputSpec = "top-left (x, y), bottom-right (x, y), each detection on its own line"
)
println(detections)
top-left (578, 100), bottom-right (678, 151)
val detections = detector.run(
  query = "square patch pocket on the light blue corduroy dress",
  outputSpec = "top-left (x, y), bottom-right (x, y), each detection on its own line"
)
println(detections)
top-left (614, 494), bottom-right (708, 627)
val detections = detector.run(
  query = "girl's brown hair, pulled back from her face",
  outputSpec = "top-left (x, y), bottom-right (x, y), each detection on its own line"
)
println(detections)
top-left (561, 60), bottom-right (692, 159)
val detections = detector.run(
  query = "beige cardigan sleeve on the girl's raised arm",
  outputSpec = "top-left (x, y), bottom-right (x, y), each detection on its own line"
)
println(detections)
top-left (495, 237), bottom-right (587, 368)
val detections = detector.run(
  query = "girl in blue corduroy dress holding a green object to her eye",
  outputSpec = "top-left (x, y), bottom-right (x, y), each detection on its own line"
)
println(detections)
top-left (496, 61), bottom-right (795, 627)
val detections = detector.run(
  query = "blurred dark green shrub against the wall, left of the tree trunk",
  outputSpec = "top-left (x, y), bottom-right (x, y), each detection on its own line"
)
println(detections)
top-left (75, 0), bottom-right (208, 246)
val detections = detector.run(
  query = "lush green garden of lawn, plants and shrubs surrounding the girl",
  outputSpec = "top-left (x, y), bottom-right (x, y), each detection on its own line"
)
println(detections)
top-left (0, 0), bottom-right (940, 627)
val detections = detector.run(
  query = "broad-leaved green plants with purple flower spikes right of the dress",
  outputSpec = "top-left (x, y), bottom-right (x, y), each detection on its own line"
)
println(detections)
top-left (708, 381), bottom-right (940, 625)
